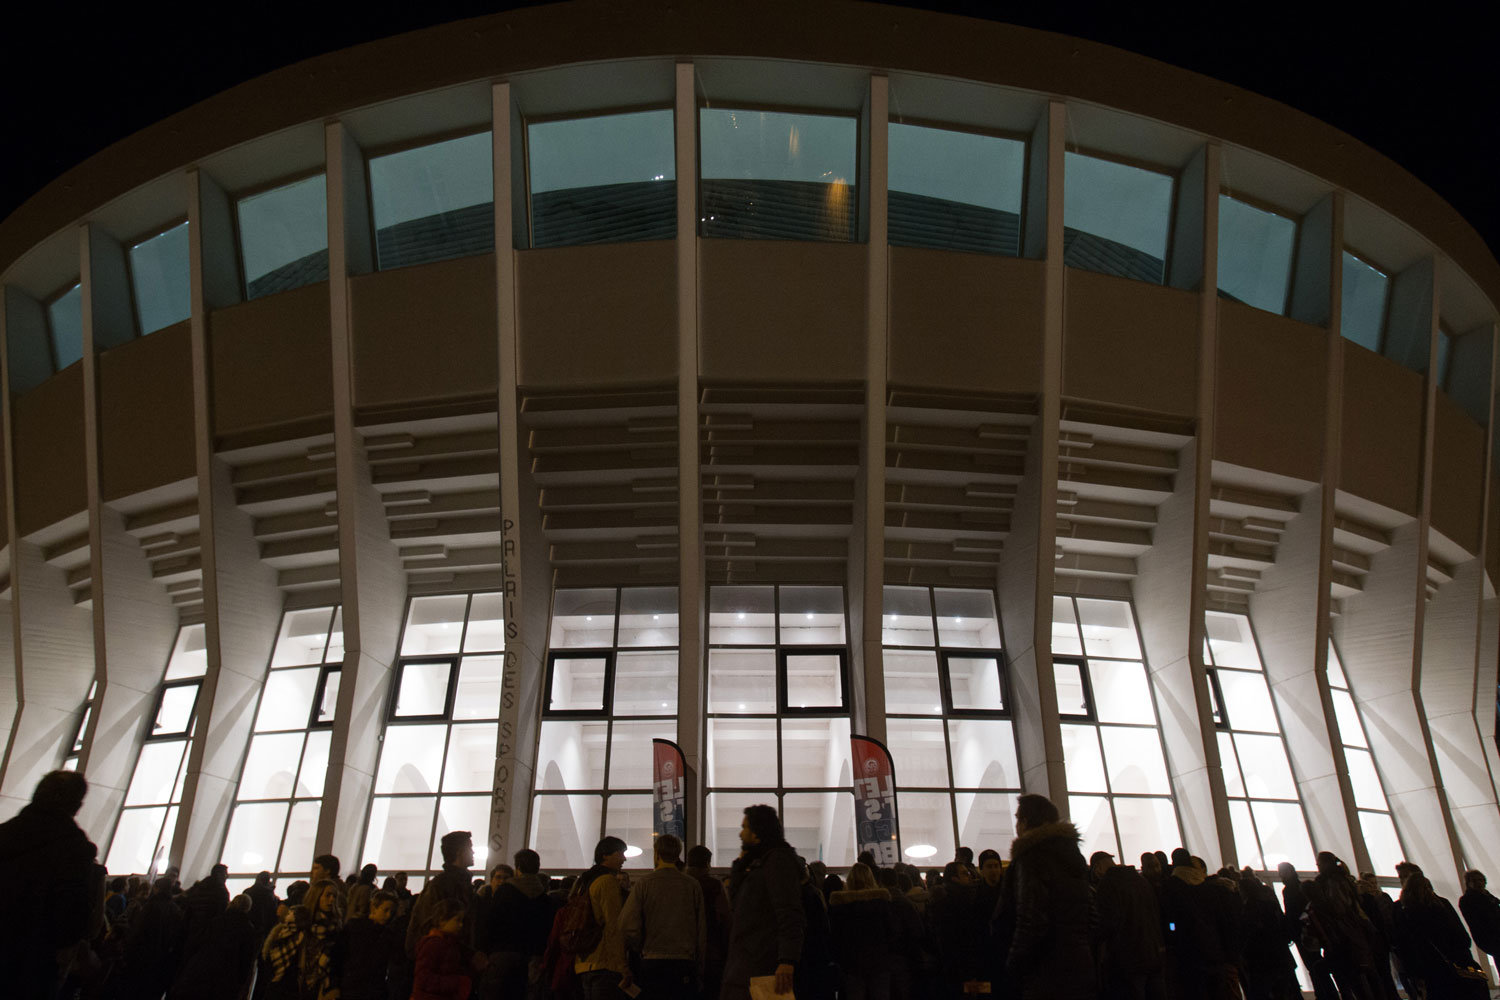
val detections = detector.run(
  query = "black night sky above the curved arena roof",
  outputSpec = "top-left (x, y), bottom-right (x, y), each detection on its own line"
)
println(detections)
top-left (0, 0), bottom-right (1500, 253)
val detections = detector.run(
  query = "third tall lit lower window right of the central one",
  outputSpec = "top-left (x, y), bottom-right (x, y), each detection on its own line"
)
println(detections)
top-left (1203, 612), bottom-right (1313, 871)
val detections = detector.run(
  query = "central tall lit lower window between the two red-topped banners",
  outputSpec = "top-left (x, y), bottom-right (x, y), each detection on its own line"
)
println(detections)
top-left (704, 586), bottom-right (858, 867)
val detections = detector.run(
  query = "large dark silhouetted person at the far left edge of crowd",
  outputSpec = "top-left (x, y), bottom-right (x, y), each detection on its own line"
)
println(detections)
top-left (0, 771), bottom-right (102, 997)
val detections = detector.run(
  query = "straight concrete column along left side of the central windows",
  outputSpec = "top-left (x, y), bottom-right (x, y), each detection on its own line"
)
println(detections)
top-left (674, 61), bottom-right (708, 843)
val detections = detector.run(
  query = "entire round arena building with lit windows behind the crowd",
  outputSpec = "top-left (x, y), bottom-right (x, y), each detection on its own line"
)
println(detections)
top-left (0, 0), bottom-right (1500, 897)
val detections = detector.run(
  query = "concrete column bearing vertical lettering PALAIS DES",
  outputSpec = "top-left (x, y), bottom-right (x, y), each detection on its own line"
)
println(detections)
top-left (489, 82), bottom-right (549, 861)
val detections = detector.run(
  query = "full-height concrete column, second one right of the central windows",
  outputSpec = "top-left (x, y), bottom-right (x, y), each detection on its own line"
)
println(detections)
top-left (999, 100), bottom-right (1068, 816)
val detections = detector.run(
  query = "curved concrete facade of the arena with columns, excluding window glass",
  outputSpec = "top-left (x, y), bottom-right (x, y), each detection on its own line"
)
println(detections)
top-left (0, 3), bottom-right (1500, 894)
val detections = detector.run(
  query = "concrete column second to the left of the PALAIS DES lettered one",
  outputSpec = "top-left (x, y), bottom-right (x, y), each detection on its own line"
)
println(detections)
top-left (170, 169), bottom-right (282, 874)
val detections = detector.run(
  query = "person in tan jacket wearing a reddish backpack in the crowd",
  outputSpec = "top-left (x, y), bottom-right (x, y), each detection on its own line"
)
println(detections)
top-left (557, 837), bottom-right (632, 1000)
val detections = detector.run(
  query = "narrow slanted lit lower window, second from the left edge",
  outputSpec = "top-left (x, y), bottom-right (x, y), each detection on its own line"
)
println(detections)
top-left (105, 625), bottom-right (209, 874)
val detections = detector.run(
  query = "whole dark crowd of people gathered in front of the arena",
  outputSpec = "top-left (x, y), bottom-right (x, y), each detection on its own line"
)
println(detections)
top-left (0, 771), bottom-right (1500, 1000)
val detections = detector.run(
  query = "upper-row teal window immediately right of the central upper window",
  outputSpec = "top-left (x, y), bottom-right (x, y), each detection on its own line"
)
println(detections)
top-left (887, 121), bottom-right (1026, 256)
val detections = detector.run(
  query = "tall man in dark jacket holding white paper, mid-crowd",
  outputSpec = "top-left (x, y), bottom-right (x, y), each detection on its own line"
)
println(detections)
top-left (722, 805), bottom-right (806, 1000)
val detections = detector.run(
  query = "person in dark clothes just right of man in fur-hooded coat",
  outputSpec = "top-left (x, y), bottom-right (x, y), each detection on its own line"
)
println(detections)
top-left (1089, 850), bottom-right (1170, 1000)
